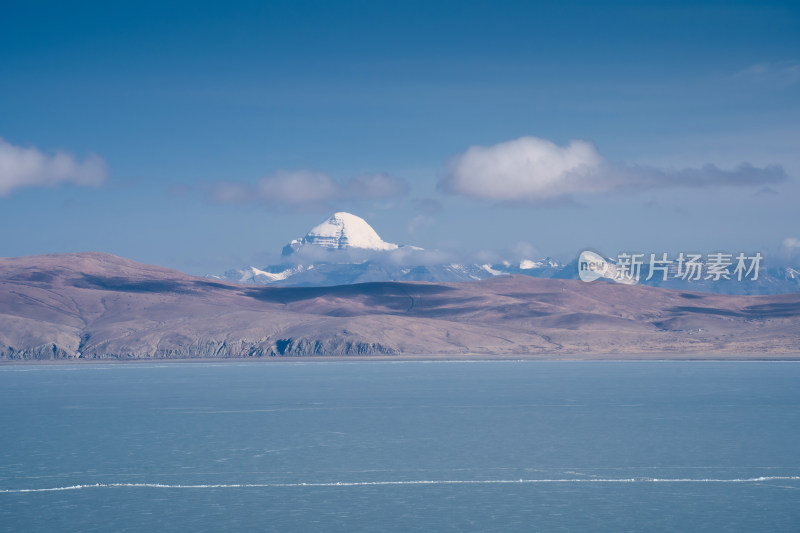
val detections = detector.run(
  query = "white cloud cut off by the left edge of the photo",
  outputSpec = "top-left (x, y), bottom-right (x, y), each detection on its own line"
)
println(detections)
top-left (0, 138), bottom-right (107, 197)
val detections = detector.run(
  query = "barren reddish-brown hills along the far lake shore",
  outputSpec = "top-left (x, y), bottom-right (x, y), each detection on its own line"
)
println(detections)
top-left (0, 250), bottom-right (800, 360)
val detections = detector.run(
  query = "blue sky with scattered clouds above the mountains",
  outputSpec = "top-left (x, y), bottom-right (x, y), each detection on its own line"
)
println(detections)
top-left (0, 0), bottom-right (800, 275)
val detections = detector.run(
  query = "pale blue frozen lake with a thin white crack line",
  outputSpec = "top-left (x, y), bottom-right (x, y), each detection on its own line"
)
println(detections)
top-left (0, 361), bottom-right (800, 532)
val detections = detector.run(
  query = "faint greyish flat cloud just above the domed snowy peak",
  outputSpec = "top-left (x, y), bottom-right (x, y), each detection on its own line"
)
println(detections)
top-left (209, 170), bottom-right (408, 207)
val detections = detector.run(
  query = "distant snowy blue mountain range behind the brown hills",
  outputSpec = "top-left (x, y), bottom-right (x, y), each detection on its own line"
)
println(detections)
top-left (214, 212), bottom-right (800, 295)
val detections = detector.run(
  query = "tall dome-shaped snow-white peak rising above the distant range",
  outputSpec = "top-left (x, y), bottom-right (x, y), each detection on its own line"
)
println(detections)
top-left (284, 212), bottom-right (398, 255)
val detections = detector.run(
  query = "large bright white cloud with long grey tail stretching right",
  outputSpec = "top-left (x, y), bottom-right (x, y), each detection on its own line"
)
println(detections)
top-left (439, 137), bottom-right (786, 204)
